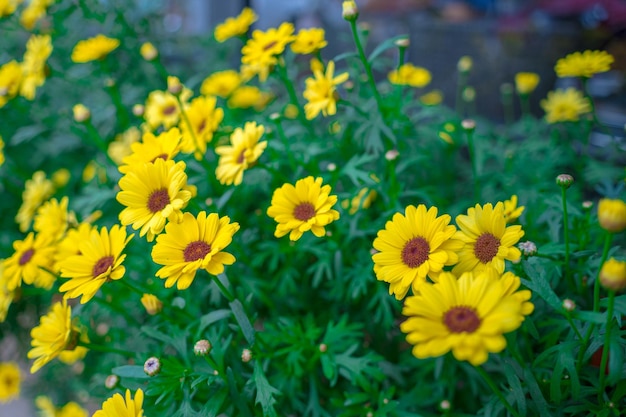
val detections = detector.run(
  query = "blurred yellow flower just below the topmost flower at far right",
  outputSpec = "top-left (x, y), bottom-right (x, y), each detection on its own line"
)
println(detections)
top-left (540, 87), bottom-right (591, 123)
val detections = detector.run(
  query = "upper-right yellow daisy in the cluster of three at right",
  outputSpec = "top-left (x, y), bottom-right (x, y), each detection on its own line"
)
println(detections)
top-left (452, 202), bottom-right (524, 275)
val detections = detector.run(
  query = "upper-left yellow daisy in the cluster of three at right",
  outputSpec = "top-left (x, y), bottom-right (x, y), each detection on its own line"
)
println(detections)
top-left (372, 204), bottom-right (463, 300)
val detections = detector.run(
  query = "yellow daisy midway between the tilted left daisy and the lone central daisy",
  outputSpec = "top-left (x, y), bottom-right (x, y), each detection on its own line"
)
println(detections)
top-left (152, 211), bottom-right (239, 290)
